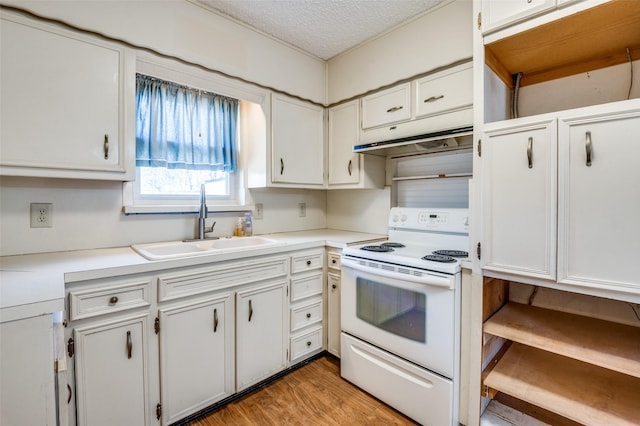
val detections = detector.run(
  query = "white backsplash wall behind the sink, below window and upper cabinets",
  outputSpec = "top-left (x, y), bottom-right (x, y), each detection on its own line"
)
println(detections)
top-left (0, 177), bottom-right (326, 256)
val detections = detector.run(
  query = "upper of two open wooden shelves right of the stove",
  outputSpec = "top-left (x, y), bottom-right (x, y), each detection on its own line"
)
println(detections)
top-left (484, 302), bottom-right (640, 380)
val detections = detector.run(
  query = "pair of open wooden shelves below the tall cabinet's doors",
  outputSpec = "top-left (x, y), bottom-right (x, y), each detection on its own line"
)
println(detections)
top-left (483, 302), bottom-right (640, 425)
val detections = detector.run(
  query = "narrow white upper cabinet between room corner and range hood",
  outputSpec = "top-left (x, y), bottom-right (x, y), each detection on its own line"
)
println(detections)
top-left (328, 100), bottom-right (385, 189)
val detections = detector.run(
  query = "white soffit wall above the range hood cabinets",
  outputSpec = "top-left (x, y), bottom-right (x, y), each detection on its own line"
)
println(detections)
top-left (328, 0), bottom-right (474, 104)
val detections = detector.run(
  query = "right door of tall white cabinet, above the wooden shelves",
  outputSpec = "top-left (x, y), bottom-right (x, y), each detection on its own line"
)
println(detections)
top-left (558, 108), bottom-right (640, 292)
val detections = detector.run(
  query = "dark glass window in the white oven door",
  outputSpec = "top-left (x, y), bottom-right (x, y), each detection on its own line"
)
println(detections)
top-left (356, 278), bottom-right (427, 343)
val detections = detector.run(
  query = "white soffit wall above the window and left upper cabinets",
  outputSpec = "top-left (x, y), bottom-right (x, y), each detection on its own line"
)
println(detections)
top-left (2, 0), bottom-right (326, 103)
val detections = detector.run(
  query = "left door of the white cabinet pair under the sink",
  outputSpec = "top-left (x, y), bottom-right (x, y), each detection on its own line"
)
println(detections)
top-left (160, 294), bottom-right (235, 424)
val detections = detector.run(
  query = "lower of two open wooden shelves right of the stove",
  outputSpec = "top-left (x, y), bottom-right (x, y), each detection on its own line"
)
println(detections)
top-left (484, 343), bottom-right (640, 426)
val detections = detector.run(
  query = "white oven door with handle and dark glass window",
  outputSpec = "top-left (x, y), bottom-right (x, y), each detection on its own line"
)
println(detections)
top-left (341, 258), bottom-right (460, 378)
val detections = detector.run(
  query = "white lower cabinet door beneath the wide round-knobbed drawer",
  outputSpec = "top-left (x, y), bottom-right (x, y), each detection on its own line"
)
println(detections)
top-left (74, 314), bottom-right (150, 426)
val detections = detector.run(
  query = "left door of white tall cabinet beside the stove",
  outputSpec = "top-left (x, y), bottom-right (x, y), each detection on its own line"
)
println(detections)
top-left (482, 120), bottom-right (557, 280)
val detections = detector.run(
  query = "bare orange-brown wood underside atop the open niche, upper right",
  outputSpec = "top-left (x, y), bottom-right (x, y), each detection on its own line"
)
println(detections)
top-left (485, 0), bottom-right (640, 87)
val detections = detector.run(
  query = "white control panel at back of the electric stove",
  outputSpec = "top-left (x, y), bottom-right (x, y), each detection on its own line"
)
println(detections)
top-left (389, 207), bottom-right (469, 234)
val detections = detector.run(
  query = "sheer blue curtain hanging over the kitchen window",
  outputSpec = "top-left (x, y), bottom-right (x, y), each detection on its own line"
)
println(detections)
top-left (136, 74), bottom-right (238, 172)
